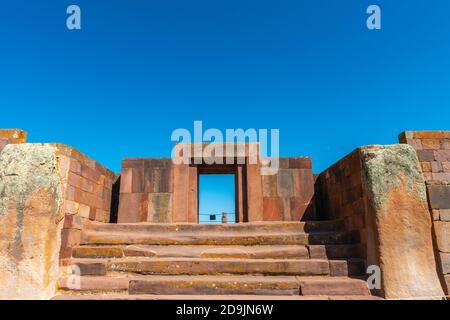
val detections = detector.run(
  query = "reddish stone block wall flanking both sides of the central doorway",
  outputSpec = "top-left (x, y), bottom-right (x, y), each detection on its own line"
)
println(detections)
top-left (118, 143), bottom-right (315, 223)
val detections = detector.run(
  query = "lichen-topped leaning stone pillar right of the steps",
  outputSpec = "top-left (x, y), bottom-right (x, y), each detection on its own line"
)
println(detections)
top-left (361, 145), bottom-right (444, 298)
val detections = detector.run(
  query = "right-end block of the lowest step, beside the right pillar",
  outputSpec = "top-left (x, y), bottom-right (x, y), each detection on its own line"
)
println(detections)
top-left (297, 277), bottom-right (370, 296)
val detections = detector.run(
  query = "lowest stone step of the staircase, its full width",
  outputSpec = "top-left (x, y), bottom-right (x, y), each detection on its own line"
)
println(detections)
top-left (59, 275), bottom-right (371, 299)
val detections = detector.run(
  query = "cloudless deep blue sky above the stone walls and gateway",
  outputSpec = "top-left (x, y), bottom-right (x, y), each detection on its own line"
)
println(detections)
top-left (0, 0), bottom-right (450, 172)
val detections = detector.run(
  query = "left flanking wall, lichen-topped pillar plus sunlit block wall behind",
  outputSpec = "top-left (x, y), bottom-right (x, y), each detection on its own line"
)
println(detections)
top-left (0, 144), bottom-right (114, 299)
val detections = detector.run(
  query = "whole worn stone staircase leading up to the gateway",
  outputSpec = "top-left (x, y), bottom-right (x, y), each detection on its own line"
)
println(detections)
top-left (55, 221), bottom-right (382, 300)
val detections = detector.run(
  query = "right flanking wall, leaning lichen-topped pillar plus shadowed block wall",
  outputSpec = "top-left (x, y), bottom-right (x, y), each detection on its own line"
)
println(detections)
top-left (316, 145), bottom-right (444, 299)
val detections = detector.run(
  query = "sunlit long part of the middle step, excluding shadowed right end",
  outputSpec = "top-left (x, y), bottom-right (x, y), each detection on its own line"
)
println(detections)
top-left (72, 245), bottom-right (309, 259)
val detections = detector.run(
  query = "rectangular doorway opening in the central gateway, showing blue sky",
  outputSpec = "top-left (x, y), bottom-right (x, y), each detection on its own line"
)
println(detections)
top-left (197, 165), bottom-right (247, 224)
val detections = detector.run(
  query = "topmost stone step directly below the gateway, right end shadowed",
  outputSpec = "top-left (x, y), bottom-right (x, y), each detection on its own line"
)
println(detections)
top-left (86, 220), bottom-right (345, 234)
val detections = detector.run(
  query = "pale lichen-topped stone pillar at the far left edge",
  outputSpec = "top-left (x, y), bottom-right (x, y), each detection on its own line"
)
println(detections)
top-left (0, 144), bottom-right (64, 299)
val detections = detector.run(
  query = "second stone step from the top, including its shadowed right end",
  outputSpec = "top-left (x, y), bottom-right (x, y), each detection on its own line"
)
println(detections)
top-left (81, 230), bottom-right (347, 246)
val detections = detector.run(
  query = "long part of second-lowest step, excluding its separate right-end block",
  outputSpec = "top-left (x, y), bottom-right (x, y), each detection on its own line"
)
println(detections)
top-left (63, 258), bottom-right (330, 276)
